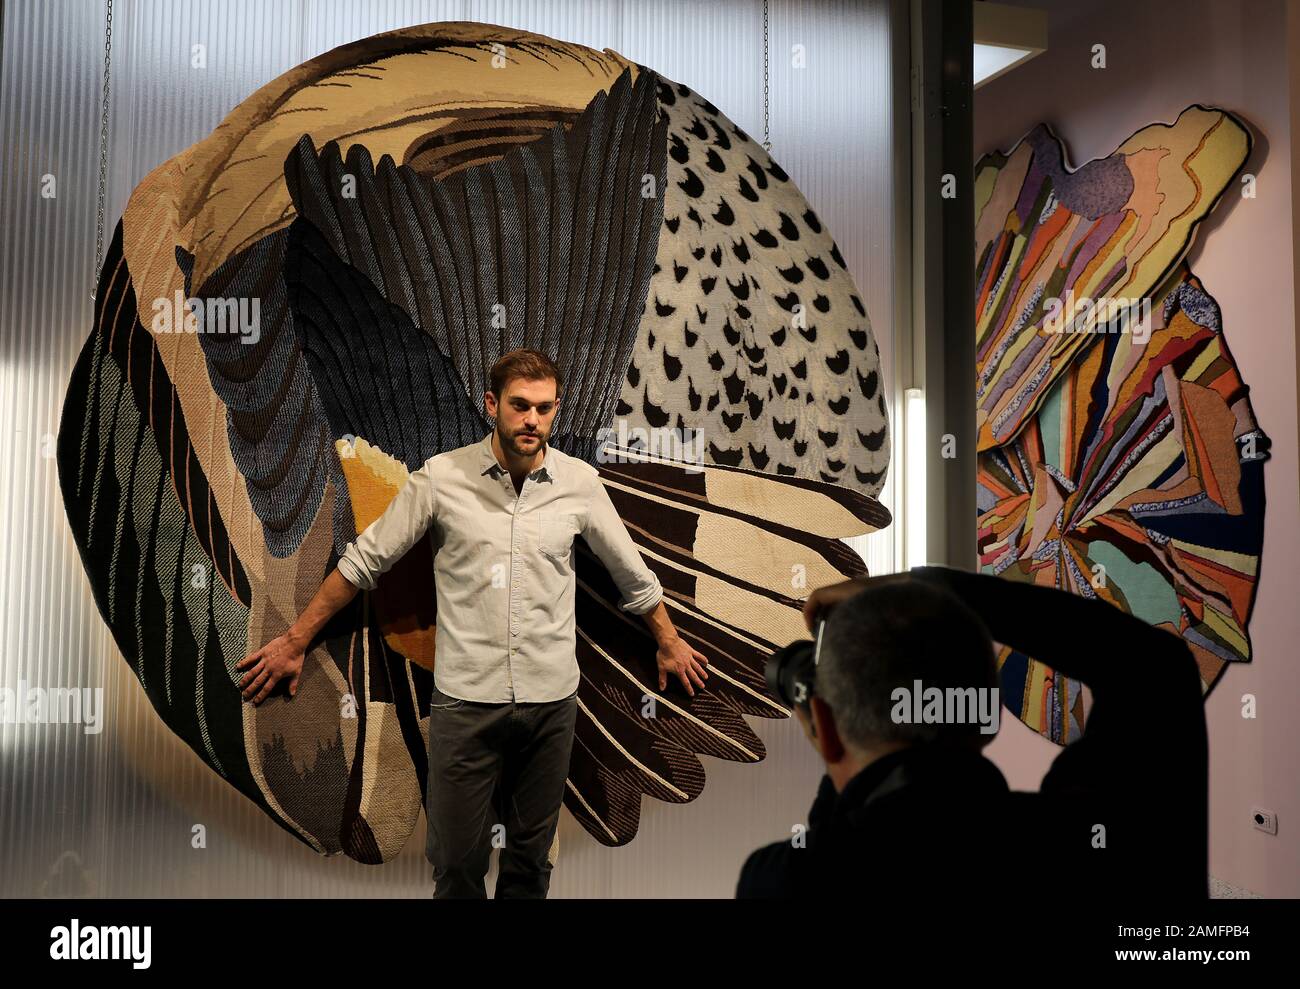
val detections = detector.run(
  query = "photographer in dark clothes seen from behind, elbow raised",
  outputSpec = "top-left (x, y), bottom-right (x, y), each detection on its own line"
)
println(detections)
top-left (736, 567), bottom-right (1208, 901)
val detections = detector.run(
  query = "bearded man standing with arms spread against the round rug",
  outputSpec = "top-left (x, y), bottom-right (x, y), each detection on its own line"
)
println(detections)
top-left (239, 350), bottom-right (709, 898)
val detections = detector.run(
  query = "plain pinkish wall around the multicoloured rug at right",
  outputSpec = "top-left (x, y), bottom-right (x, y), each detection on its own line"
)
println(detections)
top-left (975, 0), bottom-right (1300, 897)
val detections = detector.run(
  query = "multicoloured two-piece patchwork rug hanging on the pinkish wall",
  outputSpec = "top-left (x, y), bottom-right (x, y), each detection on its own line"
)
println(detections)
top-left (976, 107), bottom-right (1269, 745)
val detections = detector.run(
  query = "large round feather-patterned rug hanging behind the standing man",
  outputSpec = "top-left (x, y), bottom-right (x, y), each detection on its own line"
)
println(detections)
top-left (59, 22), bottom-right (889, 863)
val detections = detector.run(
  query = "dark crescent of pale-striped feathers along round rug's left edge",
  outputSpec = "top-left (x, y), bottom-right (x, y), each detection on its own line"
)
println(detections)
top-left (56, 224), bottom-right (293, 832)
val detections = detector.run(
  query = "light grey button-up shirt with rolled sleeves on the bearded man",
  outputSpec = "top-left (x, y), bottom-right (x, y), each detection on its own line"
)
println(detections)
top-left (338, 433), bottom-right (663, 703)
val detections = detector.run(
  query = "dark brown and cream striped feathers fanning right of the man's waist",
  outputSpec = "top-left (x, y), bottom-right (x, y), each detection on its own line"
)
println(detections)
top-left (566, 448), bottom-right (888, 845)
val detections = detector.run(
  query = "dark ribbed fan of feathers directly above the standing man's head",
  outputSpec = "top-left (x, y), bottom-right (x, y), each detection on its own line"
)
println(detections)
top-left (285, 64), bottom-right (666, 460)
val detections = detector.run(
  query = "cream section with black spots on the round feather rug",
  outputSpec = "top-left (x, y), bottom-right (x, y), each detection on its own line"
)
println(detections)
top-left (619, 79), bottom-right (889, 496)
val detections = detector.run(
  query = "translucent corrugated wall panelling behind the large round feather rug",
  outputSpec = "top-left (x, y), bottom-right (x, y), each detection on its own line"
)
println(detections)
top-left (0, 0), bottom-right (897, 897)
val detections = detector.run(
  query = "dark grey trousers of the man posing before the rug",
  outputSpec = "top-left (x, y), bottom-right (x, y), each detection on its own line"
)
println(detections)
top-left (425, 687), bottom-right (577, 899)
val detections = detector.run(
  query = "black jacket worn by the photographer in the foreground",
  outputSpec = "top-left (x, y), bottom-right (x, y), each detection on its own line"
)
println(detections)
top-left (736, 567), bottom-right (1208, 902)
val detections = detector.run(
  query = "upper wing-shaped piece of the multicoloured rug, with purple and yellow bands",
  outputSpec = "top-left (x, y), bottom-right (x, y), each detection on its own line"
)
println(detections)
top-left (975, 107), bottom-right (1251, 450)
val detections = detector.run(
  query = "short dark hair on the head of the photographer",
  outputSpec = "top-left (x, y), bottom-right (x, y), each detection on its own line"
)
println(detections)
top-left (816, 576), bottom-right (998, 749)
